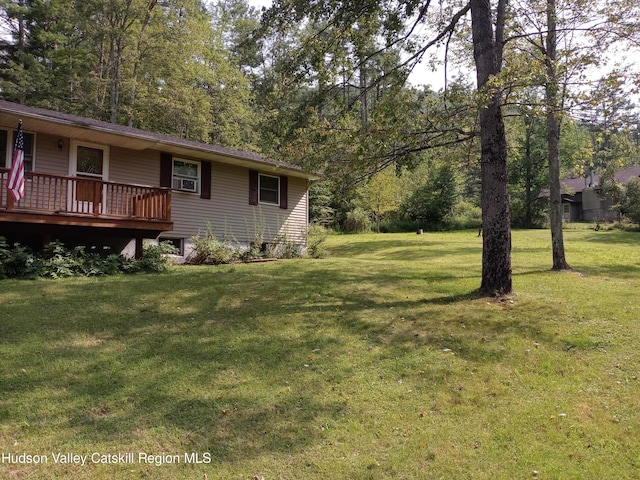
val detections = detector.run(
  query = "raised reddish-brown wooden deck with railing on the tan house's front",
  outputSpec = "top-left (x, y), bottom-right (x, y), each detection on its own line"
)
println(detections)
top-left (0, 168), bottom-right (173, 234)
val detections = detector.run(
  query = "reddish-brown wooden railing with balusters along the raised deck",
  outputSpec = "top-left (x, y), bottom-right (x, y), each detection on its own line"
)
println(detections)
top-left (0, 168), bottom-right (171, 222)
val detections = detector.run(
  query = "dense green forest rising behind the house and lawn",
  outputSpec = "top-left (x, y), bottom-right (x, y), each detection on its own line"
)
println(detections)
top-left (0, 0), bottom-right (640, 290)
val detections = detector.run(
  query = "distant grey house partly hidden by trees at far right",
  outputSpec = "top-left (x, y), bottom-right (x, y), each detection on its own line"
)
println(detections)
top-left (547, 166), bottom-right (640, 222)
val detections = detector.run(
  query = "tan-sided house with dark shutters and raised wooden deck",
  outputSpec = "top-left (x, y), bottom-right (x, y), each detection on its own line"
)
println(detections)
top-left (0, 100), bottom-right (316, 255)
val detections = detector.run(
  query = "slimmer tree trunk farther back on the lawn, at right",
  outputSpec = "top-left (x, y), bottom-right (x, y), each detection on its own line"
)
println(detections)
top-left (545, 0), bottom-right (571, 270)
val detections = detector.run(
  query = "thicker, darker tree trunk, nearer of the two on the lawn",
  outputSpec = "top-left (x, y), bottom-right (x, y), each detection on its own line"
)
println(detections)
top-left (470, 0), bottom-right (512, 295)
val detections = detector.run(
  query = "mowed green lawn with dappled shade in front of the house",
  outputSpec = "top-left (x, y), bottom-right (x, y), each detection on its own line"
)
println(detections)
top-left (0, 229), bottom-right (640, 480)
